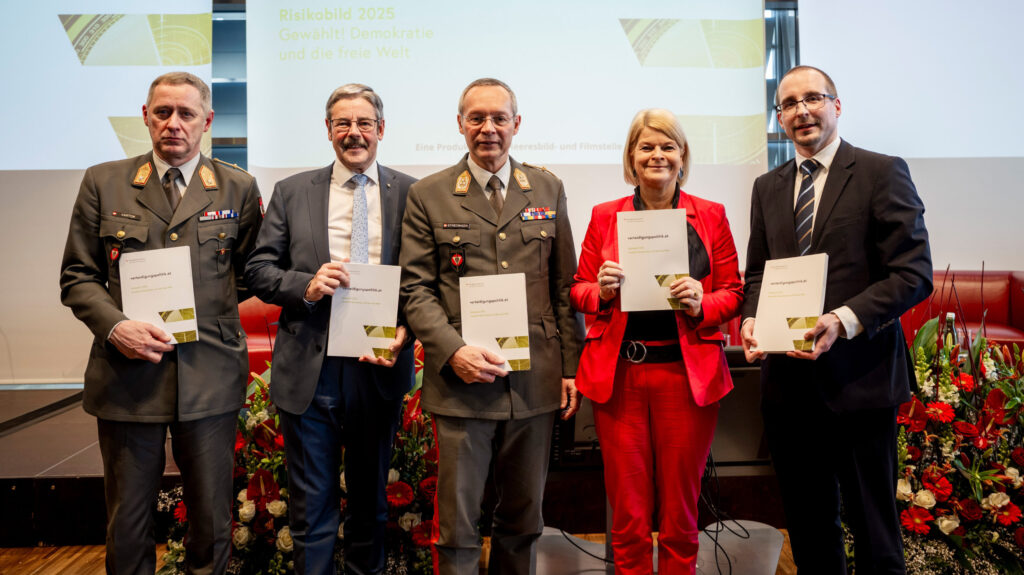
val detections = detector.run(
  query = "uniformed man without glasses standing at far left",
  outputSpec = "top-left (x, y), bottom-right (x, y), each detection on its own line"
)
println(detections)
top-left (60, 72), bottom-right (262, 573)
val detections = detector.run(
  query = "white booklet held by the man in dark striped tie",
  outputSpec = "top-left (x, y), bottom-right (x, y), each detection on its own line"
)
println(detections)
top-left (754, 254), bottom-right (828, 353)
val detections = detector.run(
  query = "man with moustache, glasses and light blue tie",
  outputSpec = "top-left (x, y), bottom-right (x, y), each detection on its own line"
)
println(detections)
top-left (246, 84), bottom-right (415, 574)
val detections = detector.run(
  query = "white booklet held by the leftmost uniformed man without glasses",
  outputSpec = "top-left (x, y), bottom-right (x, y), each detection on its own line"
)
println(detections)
top-left (118, 246), bottom-right (199, 345)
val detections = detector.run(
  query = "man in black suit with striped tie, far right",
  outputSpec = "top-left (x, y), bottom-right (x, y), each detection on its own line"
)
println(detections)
top-left (741, 67), bottom-right (932, 575)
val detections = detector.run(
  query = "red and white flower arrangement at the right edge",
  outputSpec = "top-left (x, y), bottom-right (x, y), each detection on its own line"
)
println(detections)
top-left (896, 318), bottom-right (1024, 574)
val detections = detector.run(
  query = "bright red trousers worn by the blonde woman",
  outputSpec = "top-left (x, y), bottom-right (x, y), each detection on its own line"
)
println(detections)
top-left (594, 359), bottom-right (718, 575)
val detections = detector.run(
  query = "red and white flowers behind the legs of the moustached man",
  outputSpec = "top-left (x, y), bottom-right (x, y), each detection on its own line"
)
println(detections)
top-left (157, 342), bottom-right (437, 575)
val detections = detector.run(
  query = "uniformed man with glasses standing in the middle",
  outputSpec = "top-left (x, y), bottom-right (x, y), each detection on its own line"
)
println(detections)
top-left (401, 79), bottom-right (583, 574)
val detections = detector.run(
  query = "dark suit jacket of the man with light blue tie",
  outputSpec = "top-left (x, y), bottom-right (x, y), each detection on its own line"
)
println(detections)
top-left (246, 164), bottom-right (416, 413)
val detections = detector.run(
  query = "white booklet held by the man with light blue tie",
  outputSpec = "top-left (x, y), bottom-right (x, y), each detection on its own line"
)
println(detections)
top-left (327, 263), bottom-right (401, 359)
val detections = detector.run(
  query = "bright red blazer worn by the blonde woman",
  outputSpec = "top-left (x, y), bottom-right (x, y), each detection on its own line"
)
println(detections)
top-left (571, 191), bottom-right (743, 405)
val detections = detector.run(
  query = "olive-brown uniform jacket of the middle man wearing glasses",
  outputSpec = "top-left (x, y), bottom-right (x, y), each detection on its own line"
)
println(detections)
top-left (401, 154), bottom-right (583, 419)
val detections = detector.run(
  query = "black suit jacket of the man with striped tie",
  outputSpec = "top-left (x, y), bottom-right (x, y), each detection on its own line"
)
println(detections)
top-left (742, 141), bottom-right (932, 411)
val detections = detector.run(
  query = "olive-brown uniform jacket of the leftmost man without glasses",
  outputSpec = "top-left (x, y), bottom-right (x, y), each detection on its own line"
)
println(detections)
top-left (60, 152), bottom-right (261, 423)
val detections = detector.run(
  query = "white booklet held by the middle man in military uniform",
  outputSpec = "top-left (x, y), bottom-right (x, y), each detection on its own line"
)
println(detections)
top-left (459, 273), bottom-right (529, 371)
